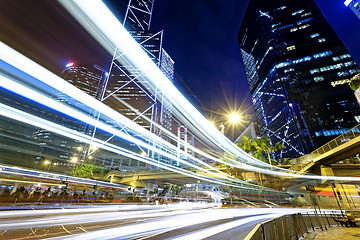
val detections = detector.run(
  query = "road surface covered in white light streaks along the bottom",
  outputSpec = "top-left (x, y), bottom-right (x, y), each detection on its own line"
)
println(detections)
top-left (0, 203), bottom-right (306, 240)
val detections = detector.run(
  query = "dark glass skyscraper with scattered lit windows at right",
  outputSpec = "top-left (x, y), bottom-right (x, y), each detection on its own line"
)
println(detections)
top-left (238, 0), bottom-right (360, 158)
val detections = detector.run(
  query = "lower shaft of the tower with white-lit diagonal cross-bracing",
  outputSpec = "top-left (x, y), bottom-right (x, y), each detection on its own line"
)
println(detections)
top-left (105, 30), bottom-right (162, 130)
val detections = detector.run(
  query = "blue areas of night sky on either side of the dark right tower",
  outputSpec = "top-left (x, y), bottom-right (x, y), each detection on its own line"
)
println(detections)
top-left (148, 0), bottom-right (360, 118)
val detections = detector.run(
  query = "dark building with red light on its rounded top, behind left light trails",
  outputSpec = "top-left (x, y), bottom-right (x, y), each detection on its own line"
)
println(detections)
top-left (33, 62), bottom-right (106, 162)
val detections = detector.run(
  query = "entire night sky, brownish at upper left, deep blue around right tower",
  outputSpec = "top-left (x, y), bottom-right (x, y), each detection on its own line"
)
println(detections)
top-left (0, 0), bottom-right (360, 131)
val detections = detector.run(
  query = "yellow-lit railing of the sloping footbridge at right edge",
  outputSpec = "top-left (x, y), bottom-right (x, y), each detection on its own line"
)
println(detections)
top-left (292, 124), bottom-right (360, 171)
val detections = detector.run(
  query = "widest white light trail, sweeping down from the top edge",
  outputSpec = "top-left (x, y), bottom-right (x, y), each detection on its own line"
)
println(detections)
top-left (60, 0), bottom-right (283, 170)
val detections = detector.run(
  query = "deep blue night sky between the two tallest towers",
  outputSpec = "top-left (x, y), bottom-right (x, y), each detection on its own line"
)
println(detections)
top-left (151, 0), bottom-right (251, 119)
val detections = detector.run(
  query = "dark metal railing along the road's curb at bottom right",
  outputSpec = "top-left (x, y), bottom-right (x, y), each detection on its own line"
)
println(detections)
top-left (245, 213), bottom-right (340, 240)
